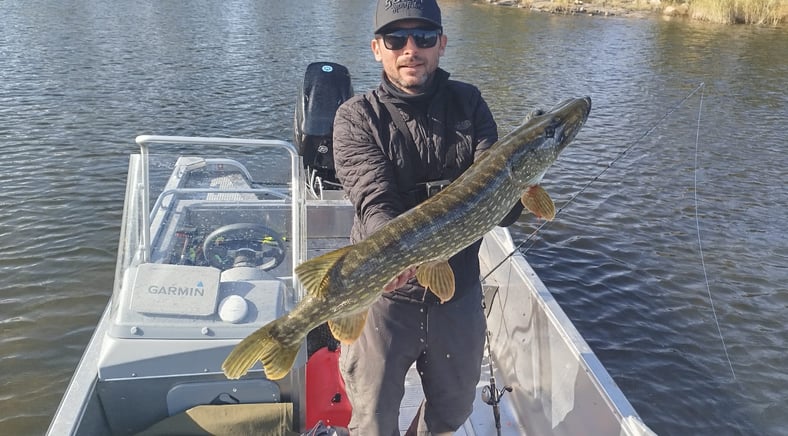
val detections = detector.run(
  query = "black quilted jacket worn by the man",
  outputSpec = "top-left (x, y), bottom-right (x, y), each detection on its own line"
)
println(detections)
top-left (333, 69), bottom-right (522, 302)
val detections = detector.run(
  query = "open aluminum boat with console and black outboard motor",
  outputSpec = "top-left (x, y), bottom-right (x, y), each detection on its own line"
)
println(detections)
top-left (47, 62), bottom-right (653, 436)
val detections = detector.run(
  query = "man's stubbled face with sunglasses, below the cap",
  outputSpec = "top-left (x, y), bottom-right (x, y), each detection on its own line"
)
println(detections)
top-left (372, 20), bottom-right (446, 94)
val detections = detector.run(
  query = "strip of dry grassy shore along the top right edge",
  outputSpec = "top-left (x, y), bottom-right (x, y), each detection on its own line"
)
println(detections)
top-left (485, 0), bottom-right (788, 26)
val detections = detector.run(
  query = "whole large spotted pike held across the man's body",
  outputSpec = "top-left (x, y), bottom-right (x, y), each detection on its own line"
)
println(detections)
top-left (222, 97), bottom-right (591, 380)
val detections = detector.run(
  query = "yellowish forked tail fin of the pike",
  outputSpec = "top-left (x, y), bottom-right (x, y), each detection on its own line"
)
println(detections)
top-left (222, 320), bottom-right (301, 380)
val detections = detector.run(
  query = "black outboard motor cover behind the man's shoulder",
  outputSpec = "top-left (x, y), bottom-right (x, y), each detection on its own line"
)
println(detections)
top-left (294, 62), bottom-right (353, 182)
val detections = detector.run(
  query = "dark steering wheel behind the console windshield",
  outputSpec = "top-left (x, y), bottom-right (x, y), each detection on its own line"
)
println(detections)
top-left (202, 223), bottom-right (285, 271)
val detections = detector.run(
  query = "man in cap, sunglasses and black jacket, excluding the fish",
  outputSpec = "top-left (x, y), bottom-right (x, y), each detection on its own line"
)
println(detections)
top-left (333, 0), bottom-right (522, 436)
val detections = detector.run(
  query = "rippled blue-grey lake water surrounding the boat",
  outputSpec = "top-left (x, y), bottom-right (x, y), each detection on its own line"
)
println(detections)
top-left (0, 0), bottom-right (788, 435)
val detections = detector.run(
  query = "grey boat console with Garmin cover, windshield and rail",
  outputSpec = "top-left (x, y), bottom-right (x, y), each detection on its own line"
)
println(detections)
top-left (97, 141), bottom-right (306, 434)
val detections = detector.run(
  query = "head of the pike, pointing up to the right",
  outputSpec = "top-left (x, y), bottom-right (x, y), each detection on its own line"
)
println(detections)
top-left (508, 97), bottom-right (591, 186)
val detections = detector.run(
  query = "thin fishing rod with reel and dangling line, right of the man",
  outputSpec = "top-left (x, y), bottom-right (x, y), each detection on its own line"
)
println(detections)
top-left (482, 82), bottom-right (736, 430)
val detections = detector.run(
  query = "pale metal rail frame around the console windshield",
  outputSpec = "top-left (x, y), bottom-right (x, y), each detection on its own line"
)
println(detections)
top-left (111, 135), bottom-right (307, 338)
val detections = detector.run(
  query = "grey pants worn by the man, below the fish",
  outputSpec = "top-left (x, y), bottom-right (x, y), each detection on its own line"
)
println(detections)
top-left (340, 289), bottom-right (486, 436)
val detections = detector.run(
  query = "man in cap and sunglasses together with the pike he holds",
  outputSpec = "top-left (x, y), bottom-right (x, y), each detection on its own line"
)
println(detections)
top-left (222, 0), bottom-right (591, 436)
